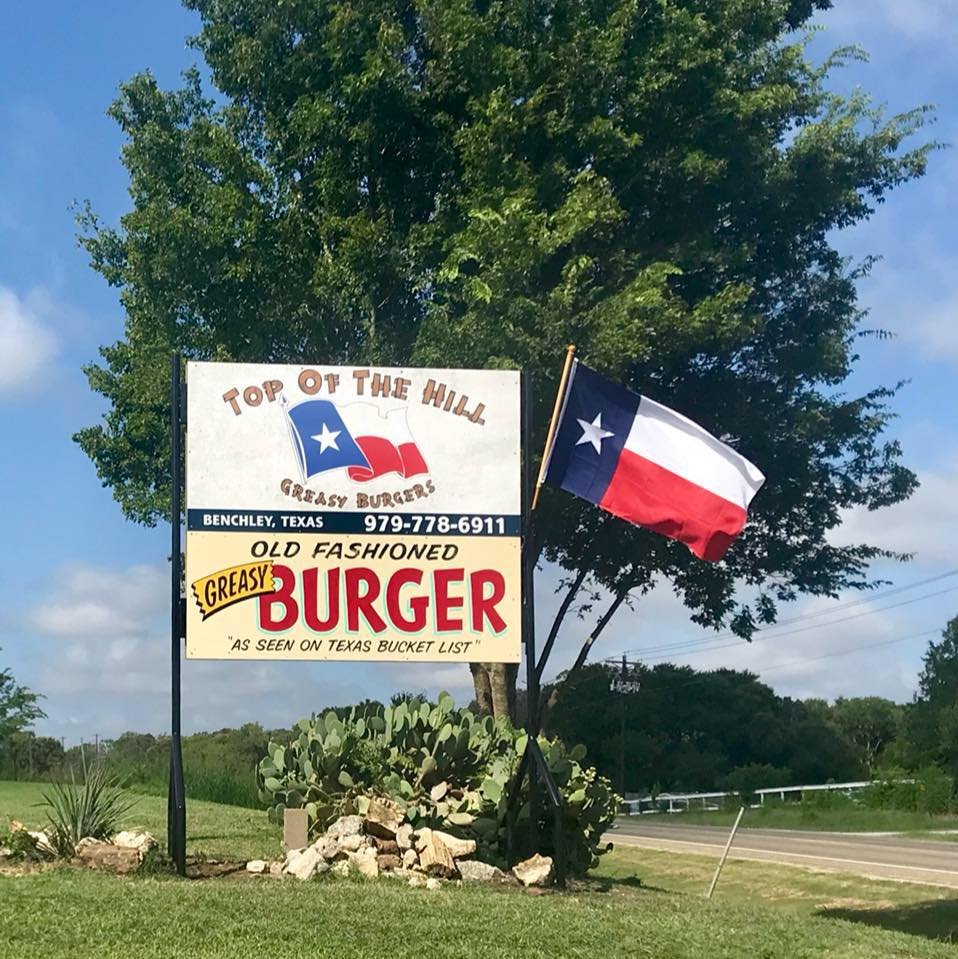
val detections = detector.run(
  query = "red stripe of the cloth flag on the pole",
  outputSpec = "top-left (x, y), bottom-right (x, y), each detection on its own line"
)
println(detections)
top-left (598, 449), bottom-right (747, 562)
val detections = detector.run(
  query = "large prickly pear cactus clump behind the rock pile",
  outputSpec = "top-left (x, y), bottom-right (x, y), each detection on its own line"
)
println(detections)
top-left (257, 693), bottom-right (617, 872)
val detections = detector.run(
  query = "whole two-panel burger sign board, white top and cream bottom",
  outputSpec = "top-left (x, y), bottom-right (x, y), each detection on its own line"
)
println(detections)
top-left (186, 363), bottom-right (521, 662)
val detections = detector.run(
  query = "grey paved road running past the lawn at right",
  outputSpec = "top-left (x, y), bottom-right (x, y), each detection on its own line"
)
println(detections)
top-left (607, 816), bottom-right (958, 889)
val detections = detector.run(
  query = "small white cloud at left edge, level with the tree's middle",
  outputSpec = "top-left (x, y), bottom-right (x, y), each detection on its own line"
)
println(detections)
top-left (0, 286), bottom-right (58, 396)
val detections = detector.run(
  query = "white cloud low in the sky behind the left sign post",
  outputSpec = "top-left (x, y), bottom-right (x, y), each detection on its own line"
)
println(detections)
top-left (26, 564), bottom-right (370, 741)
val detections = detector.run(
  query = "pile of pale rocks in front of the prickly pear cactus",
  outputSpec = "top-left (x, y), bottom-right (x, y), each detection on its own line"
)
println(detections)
top-left (253, 799), bottom-right (552, 889)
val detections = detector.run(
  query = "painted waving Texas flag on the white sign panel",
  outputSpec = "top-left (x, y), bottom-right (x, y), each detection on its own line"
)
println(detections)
top-left (286, 400), bottom-right (429, 483)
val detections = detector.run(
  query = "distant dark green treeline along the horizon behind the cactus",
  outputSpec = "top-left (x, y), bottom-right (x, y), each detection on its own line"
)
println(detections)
top-left (0, 619), bottom-right (958, 807)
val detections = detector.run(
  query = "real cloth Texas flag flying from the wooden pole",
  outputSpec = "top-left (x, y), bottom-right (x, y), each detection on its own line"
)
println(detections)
top-left (546, 361), bottom-right (765, 561)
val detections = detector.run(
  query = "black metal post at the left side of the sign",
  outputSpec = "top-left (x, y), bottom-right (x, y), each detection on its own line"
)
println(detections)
top-left (166, 353), bottom-right (186, 876)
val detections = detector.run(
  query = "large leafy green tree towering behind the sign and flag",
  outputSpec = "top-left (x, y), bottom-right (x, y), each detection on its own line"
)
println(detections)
top-left (76, 0), bottom-right (931, 712)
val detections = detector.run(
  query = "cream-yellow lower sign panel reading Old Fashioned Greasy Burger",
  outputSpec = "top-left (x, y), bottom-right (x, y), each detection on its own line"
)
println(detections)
top-left (187, 533), bottom-right (520, 662)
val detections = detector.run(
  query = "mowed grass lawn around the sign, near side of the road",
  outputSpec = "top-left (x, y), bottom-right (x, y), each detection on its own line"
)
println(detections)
top-left (0, 783), bottom-right (958, 959)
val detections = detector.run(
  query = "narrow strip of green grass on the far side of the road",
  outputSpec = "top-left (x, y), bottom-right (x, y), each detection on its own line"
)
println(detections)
top-left (642, 803), bottom-right (958, 838)
